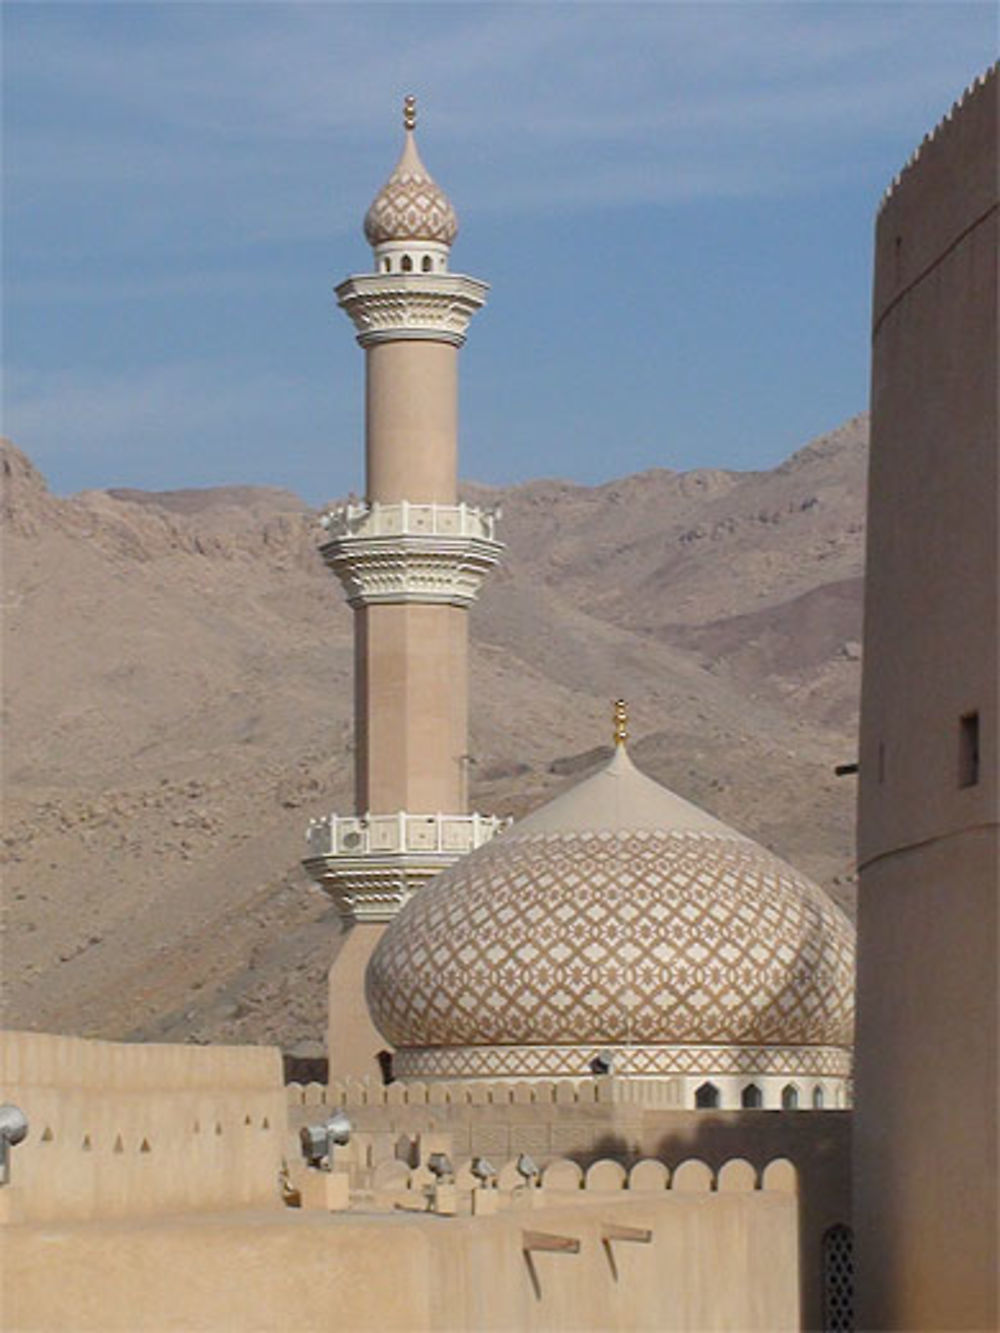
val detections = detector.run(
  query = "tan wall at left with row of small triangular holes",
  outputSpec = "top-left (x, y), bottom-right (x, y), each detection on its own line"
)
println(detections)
top-left (0, 1032), bottom-right (288, 1220)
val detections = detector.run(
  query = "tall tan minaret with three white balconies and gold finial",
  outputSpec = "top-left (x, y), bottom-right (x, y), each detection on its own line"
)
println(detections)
top-left (304, 97), bottom-right (501, 1077)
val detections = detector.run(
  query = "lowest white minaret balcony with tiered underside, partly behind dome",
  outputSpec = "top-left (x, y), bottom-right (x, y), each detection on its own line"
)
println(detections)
top-left (303, 810), bottom-right (511, 921)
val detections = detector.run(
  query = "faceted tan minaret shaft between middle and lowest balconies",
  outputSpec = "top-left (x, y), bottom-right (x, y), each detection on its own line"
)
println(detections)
top-left (355, 604), bottom-right (468, 814)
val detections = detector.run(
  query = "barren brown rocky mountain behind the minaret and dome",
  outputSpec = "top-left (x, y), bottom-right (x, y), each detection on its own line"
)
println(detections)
top-left (1, 417), bottom-right (867, 1048)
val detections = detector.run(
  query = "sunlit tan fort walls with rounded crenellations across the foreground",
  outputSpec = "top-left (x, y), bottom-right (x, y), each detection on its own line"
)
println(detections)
top-left (0, 1033), bottom-right (847, 1333)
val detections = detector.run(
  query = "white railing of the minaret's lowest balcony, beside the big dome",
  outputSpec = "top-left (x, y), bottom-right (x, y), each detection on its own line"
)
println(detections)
top-left (305, 810), bottom-right (511, 857)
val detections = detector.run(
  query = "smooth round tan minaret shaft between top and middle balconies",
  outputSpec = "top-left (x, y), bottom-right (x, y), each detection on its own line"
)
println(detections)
top-left (365, 339), bottom-right (459, 504)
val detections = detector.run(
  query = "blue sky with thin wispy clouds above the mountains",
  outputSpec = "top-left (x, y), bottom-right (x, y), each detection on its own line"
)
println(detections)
top-left (4, 0), bottom-right (997, 503)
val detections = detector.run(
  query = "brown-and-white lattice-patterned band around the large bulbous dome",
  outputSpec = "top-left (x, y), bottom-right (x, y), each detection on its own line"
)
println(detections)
top-left (367, 830), bottom-right (855, 1050)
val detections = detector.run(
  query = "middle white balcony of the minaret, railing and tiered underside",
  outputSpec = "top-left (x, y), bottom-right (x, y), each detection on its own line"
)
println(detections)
top-left (320, 500), bottom-right (503, 607)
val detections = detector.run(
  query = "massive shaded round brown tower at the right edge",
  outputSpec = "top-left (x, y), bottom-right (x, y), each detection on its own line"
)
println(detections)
top-left (855, 64), bottom-right (1000, 1329)
